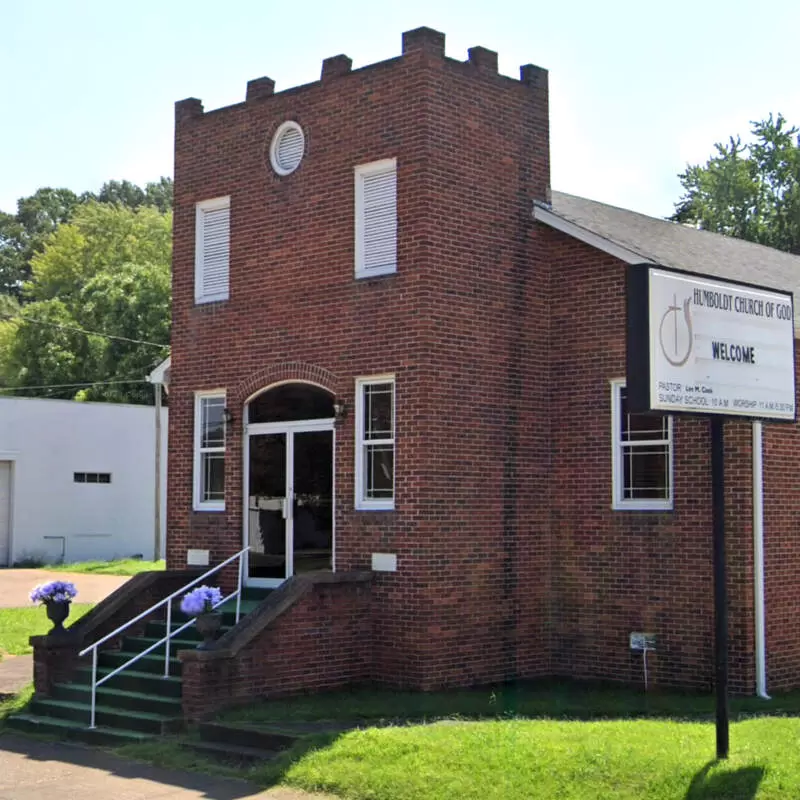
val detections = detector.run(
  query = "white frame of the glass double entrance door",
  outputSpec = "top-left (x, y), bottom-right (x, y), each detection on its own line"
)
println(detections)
top-left (242, 418), bottom-right (336, 588)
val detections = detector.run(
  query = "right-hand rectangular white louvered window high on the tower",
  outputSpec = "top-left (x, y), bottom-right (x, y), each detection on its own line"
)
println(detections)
top-left (355, 158), bottom-right (397, 278)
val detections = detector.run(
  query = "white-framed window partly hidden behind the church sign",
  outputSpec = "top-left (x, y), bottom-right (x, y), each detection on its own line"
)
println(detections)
top-left (611, 381), bottom-right (673, 511)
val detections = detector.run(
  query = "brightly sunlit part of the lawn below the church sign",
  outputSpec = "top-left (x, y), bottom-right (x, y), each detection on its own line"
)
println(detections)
top-left (276, 718), bottom-right (800, 800)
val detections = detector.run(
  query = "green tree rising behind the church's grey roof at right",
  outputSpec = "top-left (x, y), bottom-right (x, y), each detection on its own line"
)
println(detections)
top-left (672, 114), bottom-right (800, 253)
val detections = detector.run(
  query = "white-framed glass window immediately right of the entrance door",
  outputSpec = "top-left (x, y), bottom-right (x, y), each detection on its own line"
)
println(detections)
top-left (356, 375), bottom-right (395, 511)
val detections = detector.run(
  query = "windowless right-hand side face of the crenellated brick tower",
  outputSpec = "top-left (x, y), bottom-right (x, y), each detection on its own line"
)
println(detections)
top-left (404, 51), bottom-right (549, 686)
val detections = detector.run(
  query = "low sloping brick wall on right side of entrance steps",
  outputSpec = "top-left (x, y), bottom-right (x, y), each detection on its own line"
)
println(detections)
top-left (181, 583), bottom-right (372, 718)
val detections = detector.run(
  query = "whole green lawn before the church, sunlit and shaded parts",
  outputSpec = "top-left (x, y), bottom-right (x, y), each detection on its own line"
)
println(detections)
top-left (114, 681), bottom-right (800, 800)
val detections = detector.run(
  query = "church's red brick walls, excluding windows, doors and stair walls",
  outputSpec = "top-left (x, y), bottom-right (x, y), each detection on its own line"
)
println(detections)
top-left (168, 26), bottom-right (800, 691)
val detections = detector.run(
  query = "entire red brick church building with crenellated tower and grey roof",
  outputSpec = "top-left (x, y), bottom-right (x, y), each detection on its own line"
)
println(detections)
top-left (162, 28), bottom-right (800, 706)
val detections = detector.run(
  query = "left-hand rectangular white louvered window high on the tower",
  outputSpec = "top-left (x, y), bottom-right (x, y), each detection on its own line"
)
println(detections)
top-left (194, 197), bottom-right (231, 303)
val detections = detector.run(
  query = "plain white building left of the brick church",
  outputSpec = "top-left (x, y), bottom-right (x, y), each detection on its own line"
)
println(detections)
top-left (0, 397), bottom-right (167, 566)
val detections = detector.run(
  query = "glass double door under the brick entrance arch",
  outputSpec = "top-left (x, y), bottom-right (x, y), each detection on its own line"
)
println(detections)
top-left (245, 421), bottom-right (333, 586)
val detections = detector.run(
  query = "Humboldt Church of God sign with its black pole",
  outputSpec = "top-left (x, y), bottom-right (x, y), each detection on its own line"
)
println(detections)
top-left (626, 264), bottom-right (797, 759)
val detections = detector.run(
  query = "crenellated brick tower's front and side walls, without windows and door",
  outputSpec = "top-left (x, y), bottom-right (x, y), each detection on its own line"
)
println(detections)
top-left (168, 32), bottom-right (549, 686)
